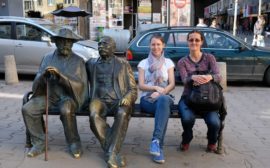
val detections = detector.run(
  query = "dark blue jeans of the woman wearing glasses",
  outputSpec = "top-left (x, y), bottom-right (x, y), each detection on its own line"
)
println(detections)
top-left (178, 98), bottom-right (220, 144)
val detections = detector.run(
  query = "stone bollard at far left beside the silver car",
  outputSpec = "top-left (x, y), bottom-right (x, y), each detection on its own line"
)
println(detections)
top-left (5, 55), bottom-right (19, 85)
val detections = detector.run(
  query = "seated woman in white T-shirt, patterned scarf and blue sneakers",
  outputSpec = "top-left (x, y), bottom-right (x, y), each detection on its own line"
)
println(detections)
top-left (138, 34), bottom-right (175, 163)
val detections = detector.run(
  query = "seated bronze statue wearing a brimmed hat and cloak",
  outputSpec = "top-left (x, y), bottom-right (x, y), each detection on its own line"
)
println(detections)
top-left (22, 28), bottom-right (88, 158)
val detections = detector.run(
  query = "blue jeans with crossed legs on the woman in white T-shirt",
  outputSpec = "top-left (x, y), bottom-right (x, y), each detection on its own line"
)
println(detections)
top-left (140, 95), bottom-right (173, 148)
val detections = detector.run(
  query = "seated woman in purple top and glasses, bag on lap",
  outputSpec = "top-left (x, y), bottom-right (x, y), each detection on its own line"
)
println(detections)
top-left (177, 30), bottom-right (221, 152)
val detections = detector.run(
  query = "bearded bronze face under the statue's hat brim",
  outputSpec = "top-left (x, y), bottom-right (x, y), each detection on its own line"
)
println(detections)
top-left (55, 38), bottom-right (73, 56)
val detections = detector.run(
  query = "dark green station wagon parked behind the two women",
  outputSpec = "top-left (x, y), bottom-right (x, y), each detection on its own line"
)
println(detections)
top-left (126, 27), bottom-right (270, 85)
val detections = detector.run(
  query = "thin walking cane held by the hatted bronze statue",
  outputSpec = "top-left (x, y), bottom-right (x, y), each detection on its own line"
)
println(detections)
top-left (44, 78), bottom-right (49, 161)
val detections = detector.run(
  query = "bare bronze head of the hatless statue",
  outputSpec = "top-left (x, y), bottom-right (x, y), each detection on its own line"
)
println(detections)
top-left (98, 38), bottom-right (115, 59)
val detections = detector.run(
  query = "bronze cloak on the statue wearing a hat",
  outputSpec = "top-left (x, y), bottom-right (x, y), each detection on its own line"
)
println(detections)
top-left (32, 51), bottom-right (88, 111)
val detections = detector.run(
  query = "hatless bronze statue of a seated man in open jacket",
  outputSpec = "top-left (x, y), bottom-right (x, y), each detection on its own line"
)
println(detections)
top-left (86, 36), bottom-right (137, 168)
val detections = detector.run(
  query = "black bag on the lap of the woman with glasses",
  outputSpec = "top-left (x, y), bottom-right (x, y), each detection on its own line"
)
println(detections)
top-left (186, 81), bottom-right (223, 112)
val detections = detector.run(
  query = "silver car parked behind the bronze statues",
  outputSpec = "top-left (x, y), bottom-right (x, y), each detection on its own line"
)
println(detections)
top-left (0, 16), bottom-right (99, 74)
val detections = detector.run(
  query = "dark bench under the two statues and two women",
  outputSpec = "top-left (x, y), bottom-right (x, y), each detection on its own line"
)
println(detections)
top-left (23, 92), bottom-right (225, 154)
